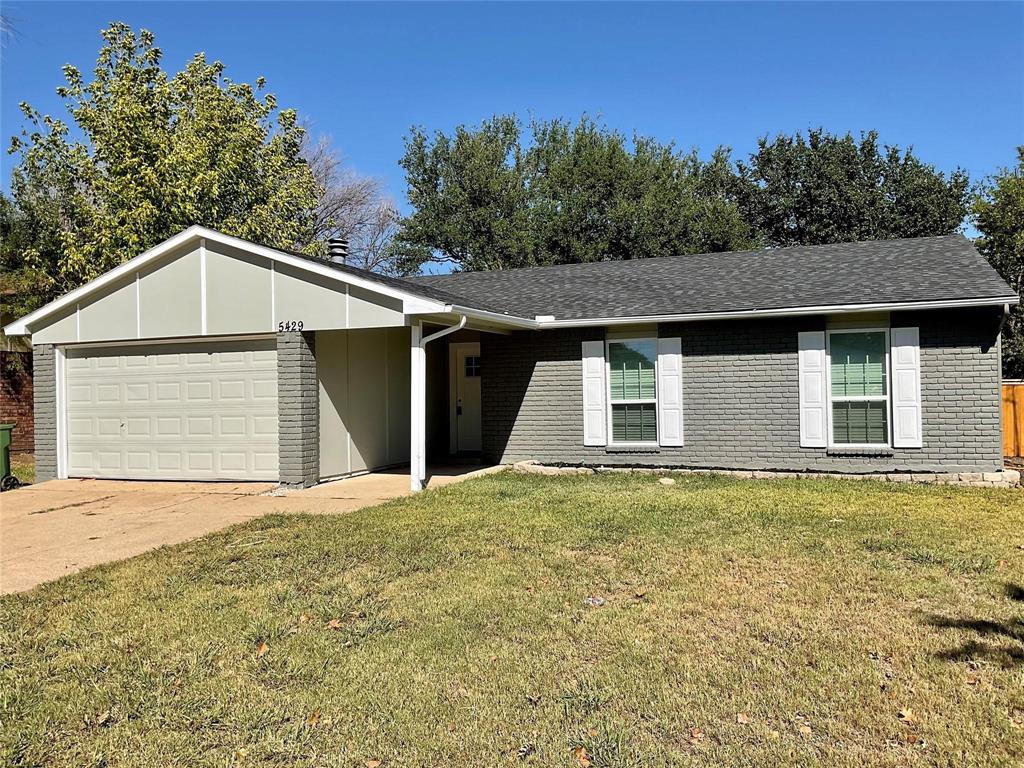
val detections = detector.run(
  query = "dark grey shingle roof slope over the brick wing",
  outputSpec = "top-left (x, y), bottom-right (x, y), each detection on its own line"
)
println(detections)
top-left (400, 234), bottom-right (1015, 321)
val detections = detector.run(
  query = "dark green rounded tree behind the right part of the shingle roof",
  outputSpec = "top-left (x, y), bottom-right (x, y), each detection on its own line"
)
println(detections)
top-left (737, 129), bottom-right (970, 246)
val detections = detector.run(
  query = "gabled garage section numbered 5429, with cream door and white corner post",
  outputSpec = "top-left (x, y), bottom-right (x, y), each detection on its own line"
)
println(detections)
top-left (4, 226), bottom-right (468, 487)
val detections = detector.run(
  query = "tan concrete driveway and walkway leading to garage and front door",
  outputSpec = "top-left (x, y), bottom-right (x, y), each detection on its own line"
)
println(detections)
top-left (0, 466), bottom-right (490, 594)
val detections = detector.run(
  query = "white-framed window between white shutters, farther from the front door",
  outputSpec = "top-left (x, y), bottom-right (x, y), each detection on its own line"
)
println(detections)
top-left (828, 330), bottom-right (889, 445)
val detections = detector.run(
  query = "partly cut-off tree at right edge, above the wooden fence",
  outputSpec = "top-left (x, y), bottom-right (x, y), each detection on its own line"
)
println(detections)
top-left (972, 145), bottom-right (1024, 379)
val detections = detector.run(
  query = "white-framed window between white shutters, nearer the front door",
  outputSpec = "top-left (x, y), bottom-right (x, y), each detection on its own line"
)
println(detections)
top-left (607, 339), bottom-right (657, 444)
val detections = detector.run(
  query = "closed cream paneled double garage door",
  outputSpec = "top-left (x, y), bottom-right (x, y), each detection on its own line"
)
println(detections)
top-left (66, 339), bottom-right (278, 480)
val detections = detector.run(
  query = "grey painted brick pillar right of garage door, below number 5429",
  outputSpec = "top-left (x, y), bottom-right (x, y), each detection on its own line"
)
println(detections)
top-left (278, 332), bottom-right (319, 487)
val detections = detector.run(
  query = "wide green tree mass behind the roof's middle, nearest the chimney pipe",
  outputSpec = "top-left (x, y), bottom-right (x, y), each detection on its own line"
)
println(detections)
top-left (395, 115), bottom-right (753, 270)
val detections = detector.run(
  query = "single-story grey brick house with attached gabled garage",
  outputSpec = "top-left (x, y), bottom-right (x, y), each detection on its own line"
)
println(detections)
top-left (5, 226), bottom-right (1018, 489)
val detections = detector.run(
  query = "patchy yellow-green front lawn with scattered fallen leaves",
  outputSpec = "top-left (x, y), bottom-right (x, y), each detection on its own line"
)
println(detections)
top-left (0, 474), bottom-right (1024, 766)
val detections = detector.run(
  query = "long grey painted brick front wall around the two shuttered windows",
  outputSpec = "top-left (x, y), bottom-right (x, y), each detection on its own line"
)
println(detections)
top-left (481, 309), bottom-right (1002, 472)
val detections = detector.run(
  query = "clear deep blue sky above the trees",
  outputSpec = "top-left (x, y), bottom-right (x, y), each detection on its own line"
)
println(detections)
top-left (0, 2), bottom-right (1024, 210)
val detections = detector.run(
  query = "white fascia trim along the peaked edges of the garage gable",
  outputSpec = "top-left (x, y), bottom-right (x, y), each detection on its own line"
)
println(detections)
top-left (3, 224), bottom-right (446, 336)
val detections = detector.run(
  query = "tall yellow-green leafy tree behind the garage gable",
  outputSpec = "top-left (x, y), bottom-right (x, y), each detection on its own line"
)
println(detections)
top-left (0, 24), bottom-right (323, 313)
